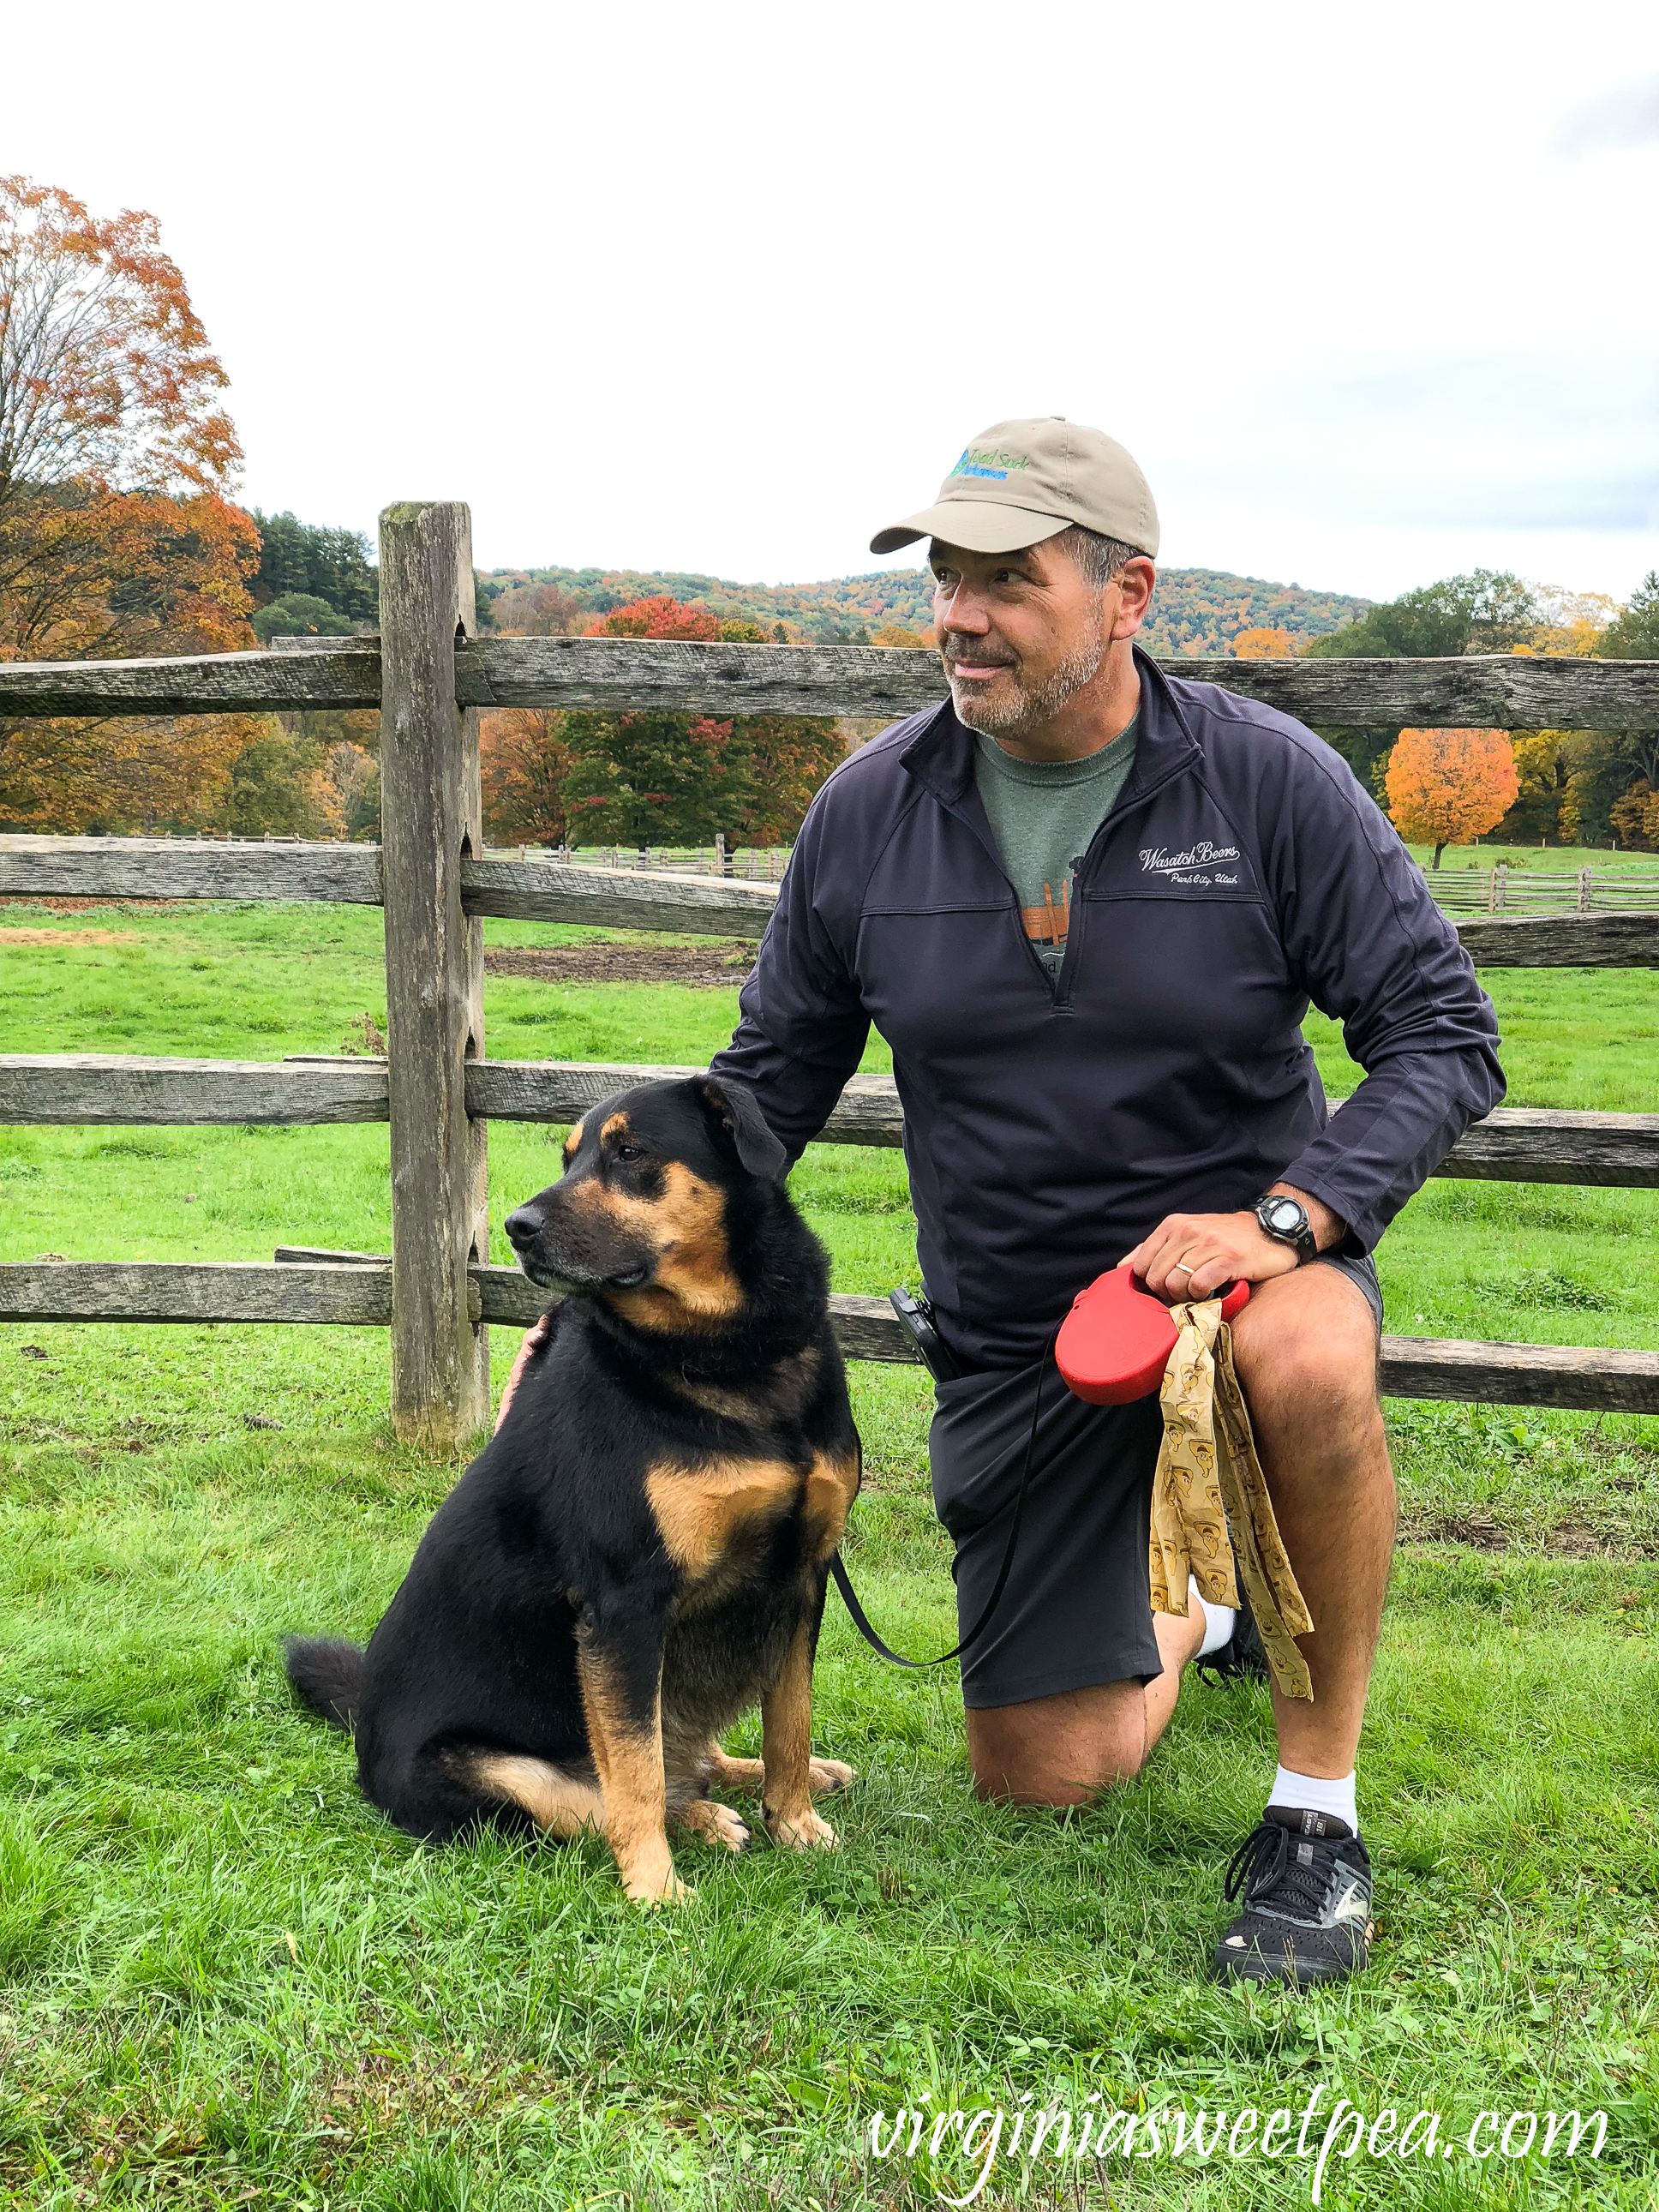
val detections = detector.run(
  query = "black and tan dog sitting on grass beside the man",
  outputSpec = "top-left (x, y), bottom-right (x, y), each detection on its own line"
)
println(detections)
top-left (288, 1077), bottom-right (859, 1903)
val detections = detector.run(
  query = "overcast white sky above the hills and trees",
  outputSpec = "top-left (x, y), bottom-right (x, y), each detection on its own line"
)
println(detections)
top-left (13, 0), bottom-right (1659, 597)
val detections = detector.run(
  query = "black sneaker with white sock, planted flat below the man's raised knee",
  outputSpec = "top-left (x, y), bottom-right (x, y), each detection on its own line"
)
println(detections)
top-left (1214, 1805), bottom-right (1374, 1988)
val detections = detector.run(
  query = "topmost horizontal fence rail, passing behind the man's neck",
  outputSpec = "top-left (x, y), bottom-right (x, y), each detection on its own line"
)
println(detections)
top-left (0, 637), bottom-right (1659, 730)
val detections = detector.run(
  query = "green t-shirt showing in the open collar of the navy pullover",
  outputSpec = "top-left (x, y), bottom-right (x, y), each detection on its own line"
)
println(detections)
top-left (973, 715), bottom-right (1141, 975)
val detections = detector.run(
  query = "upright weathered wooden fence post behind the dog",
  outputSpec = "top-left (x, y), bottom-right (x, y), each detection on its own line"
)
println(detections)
top-left (380, 500), bottom-right (488, 1451)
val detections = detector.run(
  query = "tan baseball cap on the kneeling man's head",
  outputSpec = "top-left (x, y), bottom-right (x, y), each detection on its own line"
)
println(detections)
top-left (869, 416), bottom-right (1157, 555)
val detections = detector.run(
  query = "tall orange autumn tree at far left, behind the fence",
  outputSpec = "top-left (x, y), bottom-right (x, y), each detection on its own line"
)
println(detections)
top-left (0, 177), bottom-right (261, 830)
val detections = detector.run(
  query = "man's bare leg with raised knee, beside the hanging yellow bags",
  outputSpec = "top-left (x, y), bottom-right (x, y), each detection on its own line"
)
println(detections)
top-left (1232, 1265), bottom-right (1396, 1778)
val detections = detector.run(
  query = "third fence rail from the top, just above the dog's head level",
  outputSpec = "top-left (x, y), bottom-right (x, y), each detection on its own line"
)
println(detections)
top-left (0, 1053), bottom-right (1659, 1190)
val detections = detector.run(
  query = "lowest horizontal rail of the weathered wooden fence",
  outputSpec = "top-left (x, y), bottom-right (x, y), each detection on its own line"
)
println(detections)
top-left (0, 1248), bottom-right (1659, 1413)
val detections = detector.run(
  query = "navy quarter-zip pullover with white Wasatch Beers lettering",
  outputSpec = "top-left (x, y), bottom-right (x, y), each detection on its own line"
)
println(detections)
top-left (715, 652), bottom-right (1504, 1367)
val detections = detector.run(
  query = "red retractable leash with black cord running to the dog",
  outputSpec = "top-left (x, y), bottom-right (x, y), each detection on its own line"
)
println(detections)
top-left (830, 1265), bottom-right (1249, 1668)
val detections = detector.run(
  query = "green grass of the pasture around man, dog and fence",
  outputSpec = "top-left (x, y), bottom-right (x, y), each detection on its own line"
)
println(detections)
top-left (0, 905), bottom-right (1659, 2212)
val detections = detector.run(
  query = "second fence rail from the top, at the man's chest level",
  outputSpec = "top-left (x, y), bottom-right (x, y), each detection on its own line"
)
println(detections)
top-left (0, 834), bottom-right (1659, 967)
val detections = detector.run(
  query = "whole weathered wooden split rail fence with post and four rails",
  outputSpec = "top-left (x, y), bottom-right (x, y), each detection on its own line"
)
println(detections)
top-left (0, 502), bottom-right (1659, 1449)
